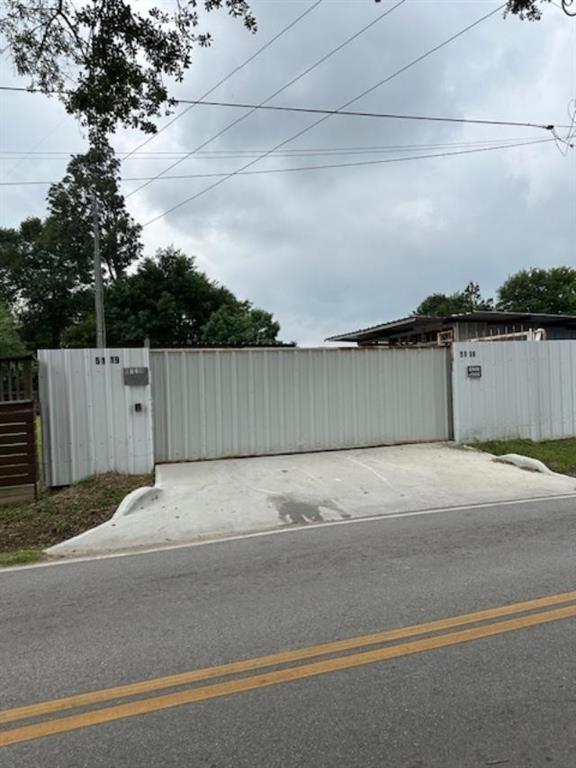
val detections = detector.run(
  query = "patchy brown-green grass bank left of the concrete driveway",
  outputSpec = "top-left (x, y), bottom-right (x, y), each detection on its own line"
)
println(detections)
top-left (0, 472), bottom-right (152, 565)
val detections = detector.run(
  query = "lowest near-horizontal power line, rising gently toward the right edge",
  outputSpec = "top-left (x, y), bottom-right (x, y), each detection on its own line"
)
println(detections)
top-left (0, 138), bottom-right (555, 187)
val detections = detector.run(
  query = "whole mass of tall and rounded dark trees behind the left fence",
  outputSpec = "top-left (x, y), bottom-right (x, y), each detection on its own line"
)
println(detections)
top-left (0, 134), bottom-right (279, 349)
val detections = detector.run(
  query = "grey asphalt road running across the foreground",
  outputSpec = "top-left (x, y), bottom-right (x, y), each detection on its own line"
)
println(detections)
top-left (0, 500), bottom-right (576, 768)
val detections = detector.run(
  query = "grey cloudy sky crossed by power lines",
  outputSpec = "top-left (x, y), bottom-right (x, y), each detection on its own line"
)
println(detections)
top-left (0, 0), bottom-right (576, 345)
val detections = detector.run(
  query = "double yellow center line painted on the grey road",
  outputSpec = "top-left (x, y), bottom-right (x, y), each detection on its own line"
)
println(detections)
top-left (0, 592), bottom-right (576, 747)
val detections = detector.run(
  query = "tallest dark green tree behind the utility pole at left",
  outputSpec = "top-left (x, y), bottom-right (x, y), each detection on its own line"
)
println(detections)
top-left (0, 140), bottom-right (142, 348)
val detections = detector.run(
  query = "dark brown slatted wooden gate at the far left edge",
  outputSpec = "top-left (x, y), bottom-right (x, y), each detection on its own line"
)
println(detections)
top-left (0, 357), bottom-right (37, 504)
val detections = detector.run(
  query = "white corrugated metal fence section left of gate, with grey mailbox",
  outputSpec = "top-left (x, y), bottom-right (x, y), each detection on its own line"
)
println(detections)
top-left (38, 348), bottom-right (154, 486)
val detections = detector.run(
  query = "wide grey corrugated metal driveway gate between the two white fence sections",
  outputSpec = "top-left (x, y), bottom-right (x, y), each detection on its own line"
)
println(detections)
top-left (150, 349), bottom-right (451, 461)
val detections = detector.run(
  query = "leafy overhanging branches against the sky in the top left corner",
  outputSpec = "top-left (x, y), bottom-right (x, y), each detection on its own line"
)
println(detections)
top-left (0, 0), bottom-right (256, 135)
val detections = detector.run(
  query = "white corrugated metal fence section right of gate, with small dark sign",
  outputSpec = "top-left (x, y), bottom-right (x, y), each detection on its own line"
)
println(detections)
top-left (453, 341), bottom-right (576, 442)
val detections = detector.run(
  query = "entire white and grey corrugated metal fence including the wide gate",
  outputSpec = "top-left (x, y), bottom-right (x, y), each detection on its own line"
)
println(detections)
top-left (38, 341), bottom-right (576, 485)
